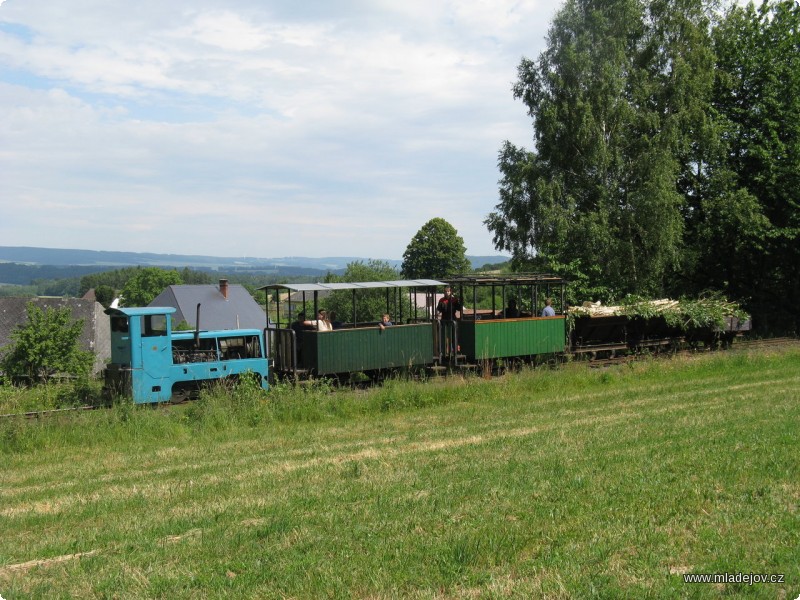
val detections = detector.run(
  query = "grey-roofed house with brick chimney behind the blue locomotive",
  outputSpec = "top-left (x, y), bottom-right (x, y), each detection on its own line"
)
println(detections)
top-left (150, 279), bottom-right (267, 330)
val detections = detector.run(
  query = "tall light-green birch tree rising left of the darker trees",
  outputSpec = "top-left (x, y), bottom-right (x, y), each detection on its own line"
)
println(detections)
top-left (485, 0), bottom-right (714, 299)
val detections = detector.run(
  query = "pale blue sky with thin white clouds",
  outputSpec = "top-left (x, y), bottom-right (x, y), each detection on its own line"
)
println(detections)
top-left (0, 0), bottom-right (562, 259)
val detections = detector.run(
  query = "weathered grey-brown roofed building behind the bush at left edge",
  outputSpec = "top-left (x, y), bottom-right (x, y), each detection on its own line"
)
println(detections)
top-left (0, 297), bottom-right (111, 375)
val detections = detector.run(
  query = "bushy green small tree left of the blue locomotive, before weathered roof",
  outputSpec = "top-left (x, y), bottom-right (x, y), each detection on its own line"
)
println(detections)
top-left (0, 302), bottom-right (94, 383)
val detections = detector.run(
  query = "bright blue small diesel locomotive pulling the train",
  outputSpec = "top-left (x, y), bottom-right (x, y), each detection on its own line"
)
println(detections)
top-left (105, 307), bottom-right (269, 404)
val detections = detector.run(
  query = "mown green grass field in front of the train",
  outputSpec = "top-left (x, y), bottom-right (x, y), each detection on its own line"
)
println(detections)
top-left (0, 349), bottom-right (800, 600)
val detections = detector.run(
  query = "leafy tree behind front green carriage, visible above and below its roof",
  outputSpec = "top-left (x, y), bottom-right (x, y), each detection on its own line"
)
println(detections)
top-left (324, 260), bottom-right (414, 323)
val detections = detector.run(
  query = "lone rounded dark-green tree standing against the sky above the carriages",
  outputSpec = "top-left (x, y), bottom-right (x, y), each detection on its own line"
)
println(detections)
top-left (402, 217), bottom-right (471, 279)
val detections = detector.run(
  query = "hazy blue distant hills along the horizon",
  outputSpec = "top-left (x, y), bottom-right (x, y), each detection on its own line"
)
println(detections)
top-left (0, 246), bottom-right (508, 285)
